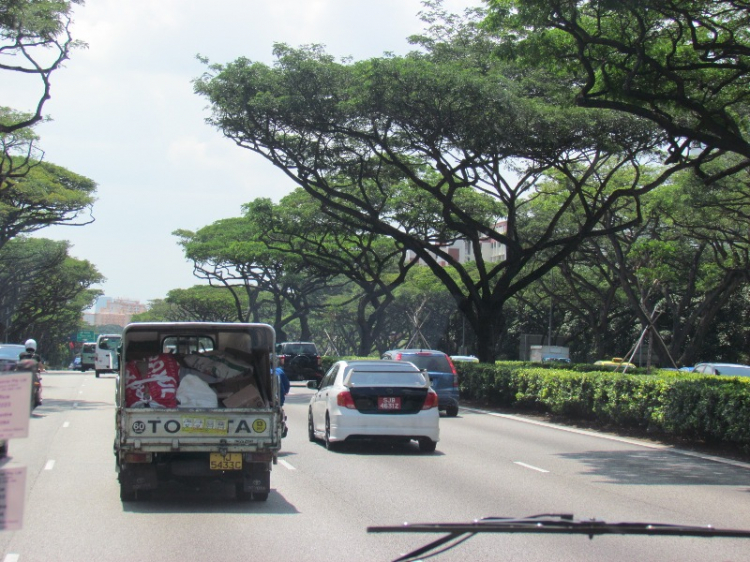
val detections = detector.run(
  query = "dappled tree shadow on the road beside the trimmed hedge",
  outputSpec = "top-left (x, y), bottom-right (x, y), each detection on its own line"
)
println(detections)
top-left (559, 450), bottom-right (750, 487)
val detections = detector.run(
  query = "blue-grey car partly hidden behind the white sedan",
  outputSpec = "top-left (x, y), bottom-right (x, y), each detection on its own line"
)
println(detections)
top-left (381, 349), bottom-right (458, 417)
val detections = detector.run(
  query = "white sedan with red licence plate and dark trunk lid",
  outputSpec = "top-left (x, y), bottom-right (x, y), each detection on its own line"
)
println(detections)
top-left (307, 361), bottom-right (440, 453)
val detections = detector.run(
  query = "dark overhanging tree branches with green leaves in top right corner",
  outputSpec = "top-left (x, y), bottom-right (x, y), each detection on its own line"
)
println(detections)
top-left (488, 0), bottom-right (750, 173)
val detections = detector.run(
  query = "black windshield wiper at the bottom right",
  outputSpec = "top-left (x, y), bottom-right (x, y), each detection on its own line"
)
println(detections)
top-left (367, 513), bottom-right (750, 562)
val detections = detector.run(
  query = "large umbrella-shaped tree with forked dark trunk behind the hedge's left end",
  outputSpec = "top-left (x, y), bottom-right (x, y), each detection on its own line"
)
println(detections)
top-left (195, 5), bottom-right (681, 361)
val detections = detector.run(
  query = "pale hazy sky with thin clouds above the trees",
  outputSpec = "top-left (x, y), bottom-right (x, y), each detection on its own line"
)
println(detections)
top-left (0, 0), bottom-right (481, 304)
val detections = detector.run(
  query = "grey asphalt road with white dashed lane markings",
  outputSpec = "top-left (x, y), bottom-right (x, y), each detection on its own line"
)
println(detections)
top-left (0, 373), bottom-right (750, 562)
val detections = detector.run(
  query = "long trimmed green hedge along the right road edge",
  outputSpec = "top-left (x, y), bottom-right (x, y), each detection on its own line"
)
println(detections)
top-left (456, 362), bottom-right (750, 453)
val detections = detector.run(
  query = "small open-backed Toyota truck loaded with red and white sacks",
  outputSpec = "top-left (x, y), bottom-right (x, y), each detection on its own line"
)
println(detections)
top-left (114, 322), bottom-right (283, 501)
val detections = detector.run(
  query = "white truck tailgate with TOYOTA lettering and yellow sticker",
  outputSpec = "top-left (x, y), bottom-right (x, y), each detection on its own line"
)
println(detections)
top-left (120, 408), bottom-right (281, 451)
